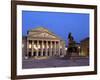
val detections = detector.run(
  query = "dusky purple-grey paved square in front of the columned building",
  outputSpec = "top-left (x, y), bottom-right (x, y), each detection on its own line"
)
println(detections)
top-left (22, 57), bottom-right (89, 69)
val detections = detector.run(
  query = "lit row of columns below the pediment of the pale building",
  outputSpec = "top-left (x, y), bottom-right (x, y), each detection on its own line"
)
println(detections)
top-left (27, 40), bottom-right (64, 56)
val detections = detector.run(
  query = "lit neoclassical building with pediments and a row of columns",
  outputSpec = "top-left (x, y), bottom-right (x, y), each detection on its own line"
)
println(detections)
top-left (22, 27), bottom-right (66, 57)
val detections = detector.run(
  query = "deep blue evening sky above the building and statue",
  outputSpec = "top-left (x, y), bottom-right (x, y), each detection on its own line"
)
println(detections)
top-left (22, 11), bottom-right (89, 42)
